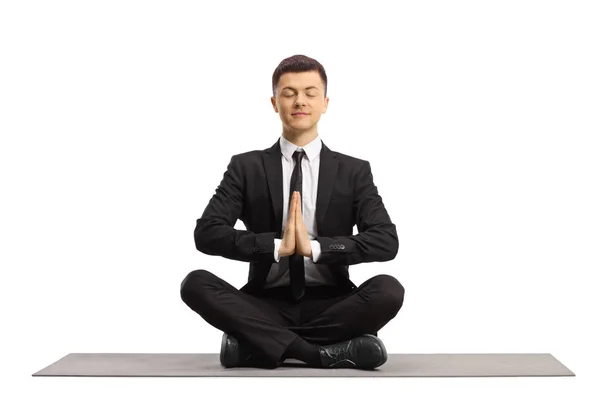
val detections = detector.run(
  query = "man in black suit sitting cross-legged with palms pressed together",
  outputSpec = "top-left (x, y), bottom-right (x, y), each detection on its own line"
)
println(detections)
top-left (181, 55), bottom-right (404, 369)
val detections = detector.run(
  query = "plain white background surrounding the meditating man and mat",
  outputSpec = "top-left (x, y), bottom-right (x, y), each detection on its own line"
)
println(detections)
top-left (0, 0), bottom-right (600, 399)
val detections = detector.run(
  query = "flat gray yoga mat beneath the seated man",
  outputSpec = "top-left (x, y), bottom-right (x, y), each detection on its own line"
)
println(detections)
top-left (33, 353), bottom-right (575, 377)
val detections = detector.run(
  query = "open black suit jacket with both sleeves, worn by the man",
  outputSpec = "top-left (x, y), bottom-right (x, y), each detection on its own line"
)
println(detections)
top-left (194, 139), bottom-right (398, 293)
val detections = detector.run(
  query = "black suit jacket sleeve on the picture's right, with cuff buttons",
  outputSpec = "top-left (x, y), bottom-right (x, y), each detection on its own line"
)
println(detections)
top-left (316, 161), bottom-right (398, 265)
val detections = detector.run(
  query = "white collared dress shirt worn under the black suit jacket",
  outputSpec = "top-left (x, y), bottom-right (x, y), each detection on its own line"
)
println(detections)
top-left (264, 135), bottom-right (335, 288)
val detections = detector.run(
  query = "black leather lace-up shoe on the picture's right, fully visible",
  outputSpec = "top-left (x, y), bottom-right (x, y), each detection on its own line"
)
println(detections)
top-left (319, 334), bottom-right (387, 369)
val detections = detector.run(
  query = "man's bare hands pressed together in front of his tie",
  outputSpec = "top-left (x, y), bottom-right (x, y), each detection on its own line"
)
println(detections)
top-left (279, 192), bottom-right (312, 258)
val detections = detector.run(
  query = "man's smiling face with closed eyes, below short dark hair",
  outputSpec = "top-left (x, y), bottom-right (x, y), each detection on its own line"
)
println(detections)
top-left (271, 71), bottom-right (329, 133)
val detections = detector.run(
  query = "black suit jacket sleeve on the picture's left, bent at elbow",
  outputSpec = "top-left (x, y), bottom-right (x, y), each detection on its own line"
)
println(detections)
top-left (194, 155), bottom-right (277, 263)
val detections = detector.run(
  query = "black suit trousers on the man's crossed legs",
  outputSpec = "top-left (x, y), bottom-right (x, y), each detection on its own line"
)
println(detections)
top-left (181, 269), bottom-right (404, 366)
